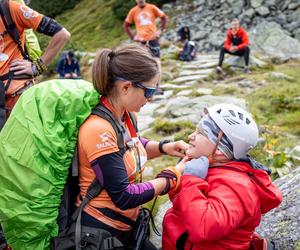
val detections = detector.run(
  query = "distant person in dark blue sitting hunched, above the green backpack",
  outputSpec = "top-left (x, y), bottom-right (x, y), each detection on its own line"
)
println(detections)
top-left (56, 51), bottom-right (80, 79)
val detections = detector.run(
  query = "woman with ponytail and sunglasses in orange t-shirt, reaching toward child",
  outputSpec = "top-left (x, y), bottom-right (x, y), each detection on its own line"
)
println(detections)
top-left (78, 44), bottom-right (188, 249)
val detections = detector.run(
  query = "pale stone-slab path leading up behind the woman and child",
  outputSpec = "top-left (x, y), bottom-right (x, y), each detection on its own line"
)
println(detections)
top-left (138, 54), bottom-right (225, 132)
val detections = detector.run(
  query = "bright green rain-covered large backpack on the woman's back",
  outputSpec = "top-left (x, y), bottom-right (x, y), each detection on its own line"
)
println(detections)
top-left (0, 79), bottom-right (138, 250)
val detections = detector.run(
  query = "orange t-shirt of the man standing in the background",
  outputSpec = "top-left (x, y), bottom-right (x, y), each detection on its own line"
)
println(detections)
top-left (125, 3), bottom-right (166, 41)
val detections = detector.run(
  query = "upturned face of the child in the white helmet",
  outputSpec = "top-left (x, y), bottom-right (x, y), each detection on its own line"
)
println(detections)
top-left (186, 128), bottom-right (215, 158)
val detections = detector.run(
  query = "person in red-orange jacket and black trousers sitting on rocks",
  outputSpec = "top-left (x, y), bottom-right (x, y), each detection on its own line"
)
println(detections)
top-left (216, 18), bottom-right (251, 73)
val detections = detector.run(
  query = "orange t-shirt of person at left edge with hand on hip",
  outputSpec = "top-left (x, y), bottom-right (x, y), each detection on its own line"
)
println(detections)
top-left (0, 1), bottom-right (43, 94)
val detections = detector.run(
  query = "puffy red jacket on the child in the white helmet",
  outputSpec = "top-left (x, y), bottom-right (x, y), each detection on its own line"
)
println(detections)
top-left (162, 162), bottom-right (282, 250)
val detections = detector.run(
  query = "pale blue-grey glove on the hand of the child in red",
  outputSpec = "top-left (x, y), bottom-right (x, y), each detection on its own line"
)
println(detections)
top-left (183, 156), bottom-right (209, 179)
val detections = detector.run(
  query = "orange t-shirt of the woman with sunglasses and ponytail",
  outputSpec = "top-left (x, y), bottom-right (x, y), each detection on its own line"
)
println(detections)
top-left (78, 115), bottom-right (147, 231)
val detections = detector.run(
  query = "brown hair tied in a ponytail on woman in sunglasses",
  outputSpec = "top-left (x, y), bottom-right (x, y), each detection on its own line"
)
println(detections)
top-left (92, 44), bottom-right (160, 96)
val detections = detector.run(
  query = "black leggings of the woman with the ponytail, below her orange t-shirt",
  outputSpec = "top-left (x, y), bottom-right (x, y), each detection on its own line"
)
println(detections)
top-left (81, 211), bottom-right (157, 250)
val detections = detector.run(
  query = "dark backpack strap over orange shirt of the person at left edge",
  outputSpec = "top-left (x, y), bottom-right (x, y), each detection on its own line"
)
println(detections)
top-left (0, 0), bottom-right (31, 61)
